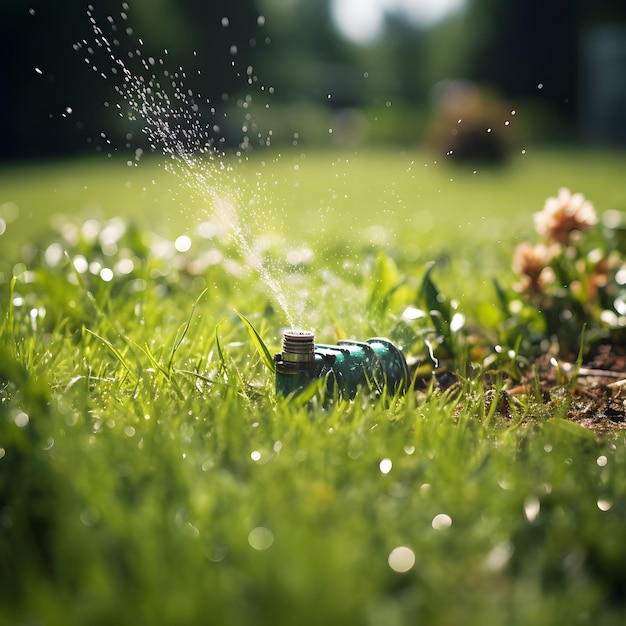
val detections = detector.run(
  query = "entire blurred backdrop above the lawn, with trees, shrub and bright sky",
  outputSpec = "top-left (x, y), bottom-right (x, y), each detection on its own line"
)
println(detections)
top-left (0, 0), bottom-right (626, 161)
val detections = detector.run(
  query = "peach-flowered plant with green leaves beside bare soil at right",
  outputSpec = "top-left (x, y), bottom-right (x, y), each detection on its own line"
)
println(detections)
top-left (512, 187), bottom-right (626, 347)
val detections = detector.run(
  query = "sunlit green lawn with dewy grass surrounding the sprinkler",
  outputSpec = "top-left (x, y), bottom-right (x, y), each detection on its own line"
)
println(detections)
top-left (0, 148), bottom-right (626, 626)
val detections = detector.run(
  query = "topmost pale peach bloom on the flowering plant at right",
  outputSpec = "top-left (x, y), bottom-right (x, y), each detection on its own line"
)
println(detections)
top-left (533, 187), bottom-right (598, 244)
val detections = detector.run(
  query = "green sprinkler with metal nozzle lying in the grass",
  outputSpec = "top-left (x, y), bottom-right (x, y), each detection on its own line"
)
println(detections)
top-left (274, 331), bottom-right (409, 399)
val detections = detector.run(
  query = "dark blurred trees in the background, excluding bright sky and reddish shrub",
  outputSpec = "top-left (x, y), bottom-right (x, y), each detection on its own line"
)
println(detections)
top-left (0, 0), bottom-right (626, 158)
